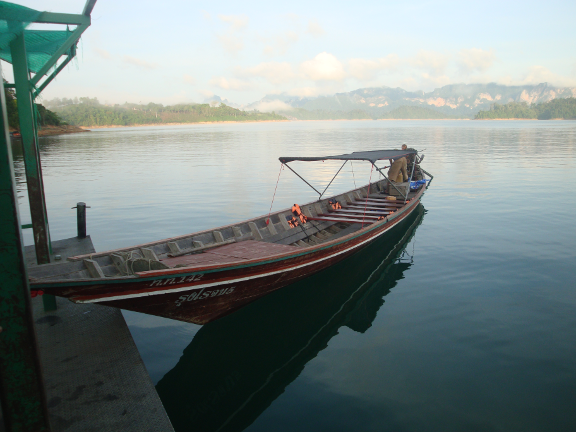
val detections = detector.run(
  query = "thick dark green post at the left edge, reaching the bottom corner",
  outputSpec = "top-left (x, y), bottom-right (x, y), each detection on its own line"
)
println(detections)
top-left (0, 62), bottom-right (50, 432)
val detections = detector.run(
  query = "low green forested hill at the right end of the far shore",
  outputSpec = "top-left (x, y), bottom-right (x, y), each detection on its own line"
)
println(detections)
top-left (475, 97), bottom-right (576, 120)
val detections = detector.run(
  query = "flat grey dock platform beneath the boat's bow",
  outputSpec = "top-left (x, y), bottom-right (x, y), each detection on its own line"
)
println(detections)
top-left (26, 238), bottom-right (174, 432)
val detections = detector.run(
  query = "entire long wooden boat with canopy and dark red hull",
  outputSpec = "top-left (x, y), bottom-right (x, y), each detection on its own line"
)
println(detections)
top-left (29, 149), bottom-right (432, 324)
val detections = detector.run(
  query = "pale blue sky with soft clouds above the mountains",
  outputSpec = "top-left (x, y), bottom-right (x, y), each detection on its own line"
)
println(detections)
top-left (2, 0), bottom-right (576, 105)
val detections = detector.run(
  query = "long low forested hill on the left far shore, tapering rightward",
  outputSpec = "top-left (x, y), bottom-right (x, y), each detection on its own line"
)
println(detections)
top-left (46, 98), bottom-right (286, 126)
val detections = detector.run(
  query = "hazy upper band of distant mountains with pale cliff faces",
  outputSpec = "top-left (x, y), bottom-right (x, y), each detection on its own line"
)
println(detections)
top-left (212, 83), bottom-right (576, 118)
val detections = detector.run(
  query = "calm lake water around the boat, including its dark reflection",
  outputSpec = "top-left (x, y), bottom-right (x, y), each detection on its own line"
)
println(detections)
top-left (15, 121), bottom-right (576, 431)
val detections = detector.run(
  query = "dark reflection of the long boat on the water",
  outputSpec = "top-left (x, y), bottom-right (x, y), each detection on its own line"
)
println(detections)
top-left (156, 204), bottom-right (425, 432)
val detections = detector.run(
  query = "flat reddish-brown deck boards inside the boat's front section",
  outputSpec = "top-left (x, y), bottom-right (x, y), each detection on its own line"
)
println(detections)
top-left (160, 240), bottom-right (299, 267)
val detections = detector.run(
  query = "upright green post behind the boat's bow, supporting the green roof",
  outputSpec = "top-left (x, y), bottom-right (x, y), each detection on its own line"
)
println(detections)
top-left (10, 28), bottom-right (50, 264)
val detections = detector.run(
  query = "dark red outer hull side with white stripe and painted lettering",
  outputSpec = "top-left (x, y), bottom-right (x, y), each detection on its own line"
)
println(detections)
top-left (32, 188), bottom-right (424, 324)
